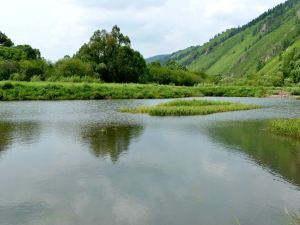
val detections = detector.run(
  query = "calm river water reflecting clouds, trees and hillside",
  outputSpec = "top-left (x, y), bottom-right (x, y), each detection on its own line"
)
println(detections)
top-left (0, 98), bottom-right (300, 225)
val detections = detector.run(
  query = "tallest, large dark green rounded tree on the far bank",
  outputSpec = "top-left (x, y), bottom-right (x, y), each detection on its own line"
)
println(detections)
top-left (75, 26), bottom-right (147, 82)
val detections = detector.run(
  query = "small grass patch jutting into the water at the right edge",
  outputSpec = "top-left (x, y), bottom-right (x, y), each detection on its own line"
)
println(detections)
top-left (268, 119), bottom-right (300, 139)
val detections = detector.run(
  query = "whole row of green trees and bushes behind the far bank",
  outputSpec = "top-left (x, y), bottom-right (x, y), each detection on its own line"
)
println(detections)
top-left (0, 26), bottom-right (205, 85)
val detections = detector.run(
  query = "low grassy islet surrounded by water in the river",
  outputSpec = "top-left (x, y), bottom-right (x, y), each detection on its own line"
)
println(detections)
top-left (120, 100), bottom-right (259, 116)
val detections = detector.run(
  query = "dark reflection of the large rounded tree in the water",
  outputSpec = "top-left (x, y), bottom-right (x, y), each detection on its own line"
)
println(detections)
top-left (82, 125), bottom-right (143, 162)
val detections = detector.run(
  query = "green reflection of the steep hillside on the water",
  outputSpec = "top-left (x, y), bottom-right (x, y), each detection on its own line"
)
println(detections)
top-left (209, 121), bottom-right (300, 187)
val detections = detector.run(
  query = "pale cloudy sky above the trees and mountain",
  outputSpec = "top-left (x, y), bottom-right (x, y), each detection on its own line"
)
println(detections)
top-left (0, 0), bottom-right (284, 61)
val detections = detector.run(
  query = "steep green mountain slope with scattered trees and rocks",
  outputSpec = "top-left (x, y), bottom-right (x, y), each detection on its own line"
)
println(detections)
top-left (151, 0), bottom-right (300, 76)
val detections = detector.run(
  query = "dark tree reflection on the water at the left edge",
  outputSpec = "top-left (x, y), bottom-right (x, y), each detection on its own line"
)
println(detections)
top-left (0, 121), bottom-right (39, 153)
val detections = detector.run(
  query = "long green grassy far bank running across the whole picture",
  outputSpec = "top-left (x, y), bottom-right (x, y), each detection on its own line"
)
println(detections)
top-left (0, 81), bottom-right (300, 101)
